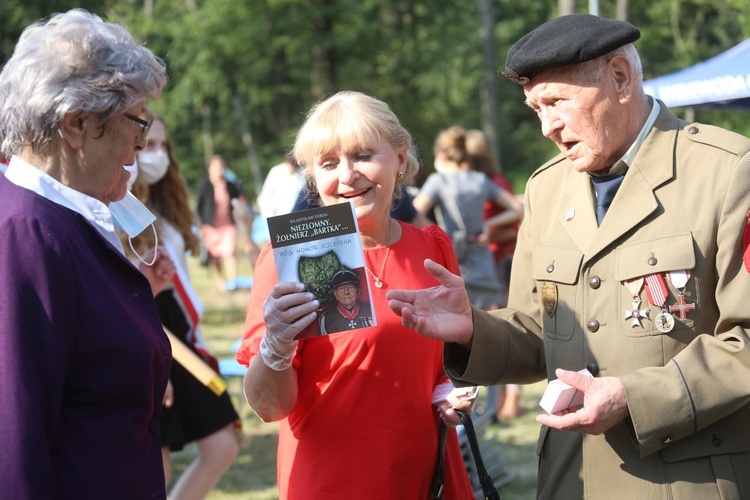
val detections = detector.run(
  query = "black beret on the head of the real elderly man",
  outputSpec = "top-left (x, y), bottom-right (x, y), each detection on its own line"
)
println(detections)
top-left (500, 14), bottom-right (641, 85)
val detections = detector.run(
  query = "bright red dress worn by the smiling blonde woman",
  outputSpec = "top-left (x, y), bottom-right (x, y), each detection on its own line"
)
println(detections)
top-left (237, 223), bottom-right (474, 500)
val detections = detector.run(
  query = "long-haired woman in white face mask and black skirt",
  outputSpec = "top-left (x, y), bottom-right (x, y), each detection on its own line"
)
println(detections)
top-left (122, 109), bottom-right (240, 500)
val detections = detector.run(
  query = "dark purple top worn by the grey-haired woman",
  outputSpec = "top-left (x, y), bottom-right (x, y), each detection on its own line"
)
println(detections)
top-left (0, 176), bottom-right (171, 500)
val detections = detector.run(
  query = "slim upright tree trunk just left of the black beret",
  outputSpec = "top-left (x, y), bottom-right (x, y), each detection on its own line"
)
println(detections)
top-left (478, 0), bottom-right (503, 172)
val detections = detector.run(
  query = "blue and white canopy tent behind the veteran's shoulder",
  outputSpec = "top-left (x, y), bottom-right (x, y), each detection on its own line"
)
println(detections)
top-left (643, 39), bottom-right (750, 108)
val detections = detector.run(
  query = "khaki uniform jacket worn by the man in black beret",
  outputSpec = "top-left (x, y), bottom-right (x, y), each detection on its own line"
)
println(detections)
top-left (445, 104), bottom-right (750, 500)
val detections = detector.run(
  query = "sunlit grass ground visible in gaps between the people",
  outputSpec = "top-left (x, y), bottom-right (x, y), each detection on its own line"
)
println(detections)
top-left (180, 254), bottom-right (544, 500)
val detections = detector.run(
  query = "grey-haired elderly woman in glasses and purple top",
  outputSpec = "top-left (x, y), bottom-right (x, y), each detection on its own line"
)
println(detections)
top-left (0, 9), bottom-right (171, 499)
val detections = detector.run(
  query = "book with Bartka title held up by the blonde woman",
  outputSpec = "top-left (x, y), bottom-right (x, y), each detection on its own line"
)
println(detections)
top-left (268, 202), bottom-right (377, 338)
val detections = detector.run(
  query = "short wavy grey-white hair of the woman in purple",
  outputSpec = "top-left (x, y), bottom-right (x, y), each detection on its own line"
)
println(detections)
top-left (0, 9), bottom-right (166, 157)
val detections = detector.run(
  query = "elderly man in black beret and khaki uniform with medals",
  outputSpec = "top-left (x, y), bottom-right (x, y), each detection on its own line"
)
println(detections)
top-left (388, 15), bottom-right (750, 499)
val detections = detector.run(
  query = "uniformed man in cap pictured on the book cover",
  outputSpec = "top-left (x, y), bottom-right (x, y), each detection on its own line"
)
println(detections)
top-left (318, 269), bottom-right (372, 335)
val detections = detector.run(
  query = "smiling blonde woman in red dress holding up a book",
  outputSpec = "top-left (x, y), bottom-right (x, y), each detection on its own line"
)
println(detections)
top-left (237, 92), bottom-right (474, 500)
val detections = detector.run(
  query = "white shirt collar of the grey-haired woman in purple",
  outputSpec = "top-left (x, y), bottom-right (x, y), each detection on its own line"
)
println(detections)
top-left (5, 156), bottom-right (125, 255)
